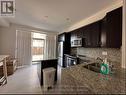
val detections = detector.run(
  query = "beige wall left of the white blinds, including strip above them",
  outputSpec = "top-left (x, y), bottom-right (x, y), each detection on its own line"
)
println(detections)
top-left (0, 24), bottom-right (58, 57)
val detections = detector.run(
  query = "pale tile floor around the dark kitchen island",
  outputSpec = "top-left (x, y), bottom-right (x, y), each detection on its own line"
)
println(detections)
top-left (0, 65), bottom-right (79, 94)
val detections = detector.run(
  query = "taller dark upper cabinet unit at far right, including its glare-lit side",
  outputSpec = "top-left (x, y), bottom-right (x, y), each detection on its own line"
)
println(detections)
top-left (101, 7), bottom-right (122, 48)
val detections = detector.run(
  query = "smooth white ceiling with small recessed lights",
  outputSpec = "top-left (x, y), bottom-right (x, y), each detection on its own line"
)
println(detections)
top-left (4, 0), bottom-right (120, 32)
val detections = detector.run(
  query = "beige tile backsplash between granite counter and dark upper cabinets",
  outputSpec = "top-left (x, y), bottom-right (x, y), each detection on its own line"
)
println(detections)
top-left (71, 47), bottom-right (121, 63)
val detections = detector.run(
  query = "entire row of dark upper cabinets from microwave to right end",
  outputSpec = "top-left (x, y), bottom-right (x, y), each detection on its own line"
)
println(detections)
top-left (71, 7), bottom-right (122, 48)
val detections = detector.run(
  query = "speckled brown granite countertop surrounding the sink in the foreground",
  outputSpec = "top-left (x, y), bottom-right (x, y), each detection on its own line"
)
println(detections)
top-left (61, 59), bottom-right (126, 94)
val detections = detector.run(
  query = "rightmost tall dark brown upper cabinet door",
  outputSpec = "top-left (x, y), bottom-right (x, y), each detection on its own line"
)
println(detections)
top-left (106, 8), bottom-right (122, 48)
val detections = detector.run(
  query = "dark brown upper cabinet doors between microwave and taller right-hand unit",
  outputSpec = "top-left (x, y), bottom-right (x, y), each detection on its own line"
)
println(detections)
top-left (83, 21), bottom-right (100, 48)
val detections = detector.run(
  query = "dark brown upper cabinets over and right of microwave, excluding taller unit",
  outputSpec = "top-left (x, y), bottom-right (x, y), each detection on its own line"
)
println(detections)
top-left (71, 21), bottom-right (100, 48)
